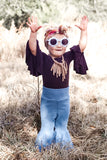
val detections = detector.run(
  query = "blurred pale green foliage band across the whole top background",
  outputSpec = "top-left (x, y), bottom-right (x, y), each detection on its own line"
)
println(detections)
top-left (0, 0), bottom-right (107, 29)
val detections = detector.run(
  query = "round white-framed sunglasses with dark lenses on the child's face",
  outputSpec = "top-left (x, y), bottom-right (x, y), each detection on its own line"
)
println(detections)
top-left (47, 37), bottom-right (69, 47)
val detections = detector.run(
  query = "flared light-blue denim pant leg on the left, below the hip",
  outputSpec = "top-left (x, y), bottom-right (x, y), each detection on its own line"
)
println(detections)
top-left (35, 98), bottom-right (57, 151)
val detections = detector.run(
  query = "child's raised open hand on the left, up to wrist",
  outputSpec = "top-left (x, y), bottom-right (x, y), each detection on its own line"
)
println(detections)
top-left (26, 16), bottom-right (42, 33)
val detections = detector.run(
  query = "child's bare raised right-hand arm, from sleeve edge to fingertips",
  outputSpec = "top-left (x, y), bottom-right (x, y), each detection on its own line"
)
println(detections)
top-left (75, 16), bottom-right (88, 52)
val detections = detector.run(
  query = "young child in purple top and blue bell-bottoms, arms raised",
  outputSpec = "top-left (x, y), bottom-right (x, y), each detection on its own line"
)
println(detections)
top-left (26, 16), bottom-right (88, 151)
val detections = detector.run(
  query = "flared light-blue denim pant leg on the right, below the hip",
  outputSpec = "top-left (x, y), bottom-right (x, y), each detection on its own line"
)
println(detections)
top-left (55, 98), bottom-right (73, 148)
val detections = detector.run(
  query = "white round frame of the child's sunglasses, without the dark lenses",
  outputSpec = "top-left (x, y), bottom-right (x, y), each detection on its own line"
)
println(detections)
top-left (47, 37), bottom-right (69, 47)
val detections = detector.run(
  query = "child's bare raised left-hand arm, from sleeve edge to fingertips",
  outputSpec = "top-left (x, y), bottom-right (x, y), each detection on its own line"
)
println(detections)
top-left (26, 16), bottom-right (41, 56)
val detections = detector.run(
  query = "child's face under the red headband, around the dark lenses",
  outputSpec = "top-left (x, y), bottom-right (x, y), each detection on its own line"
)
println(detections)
top-left (48, 34), bottom-right (66, 58)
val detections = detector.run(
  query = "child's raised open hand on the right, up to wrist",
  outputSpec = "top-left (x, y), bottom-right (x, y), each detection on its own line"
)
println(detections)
top-left (75, 16), bottom-right (88, 31)
